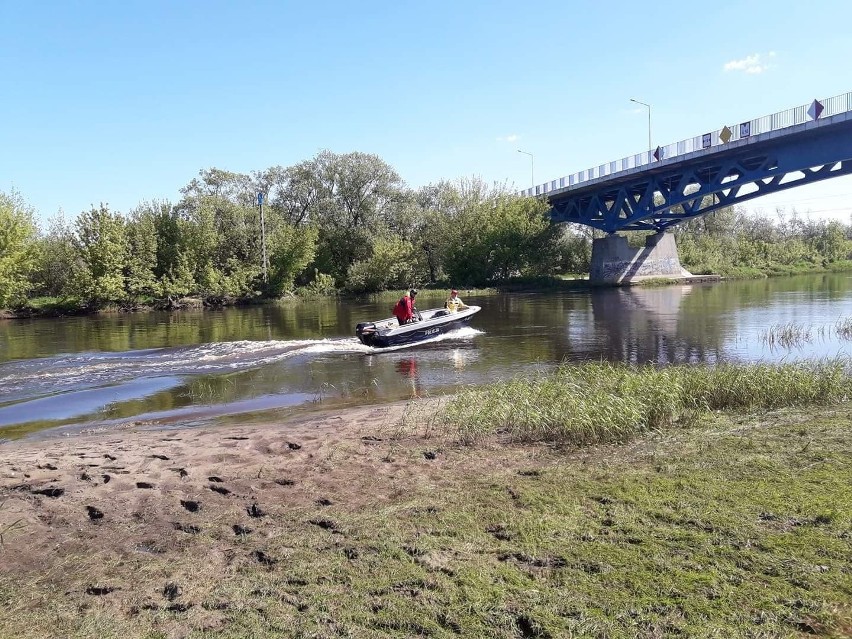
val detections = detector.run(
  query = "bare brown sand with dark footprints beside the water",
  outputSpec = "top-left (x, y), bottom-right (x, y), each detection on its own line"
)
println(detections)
top-left (0, 403), bottom-right (452, 573)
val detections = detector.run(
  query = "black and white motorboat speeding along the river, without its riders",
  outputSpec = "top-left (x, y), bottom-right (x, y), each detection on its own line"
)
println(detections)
top-left (355, 306), bottom-right (482, 348)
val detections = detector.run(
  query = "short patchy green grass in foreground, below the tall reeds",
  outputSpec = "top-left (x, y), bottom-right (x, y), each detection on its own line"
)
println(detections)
top-left (0, 410), bottom-right (852, 639)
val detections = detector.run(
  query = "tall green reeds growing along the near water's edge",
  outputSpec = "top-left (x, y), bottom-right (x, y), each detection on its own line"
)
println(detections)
top-left (439, 359), bottom-right (852, 446)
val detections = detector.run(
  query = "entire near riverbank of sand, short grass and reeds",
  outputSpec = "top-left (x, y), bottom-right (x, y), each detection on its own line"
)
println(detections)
top-left (0, 360), bottom-right (852, 639)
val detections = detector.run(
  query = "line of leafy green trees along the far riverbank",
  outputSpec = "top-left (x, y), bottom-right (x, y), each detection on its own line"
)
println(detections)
top-left (0, 151), bottom-right (852, 309)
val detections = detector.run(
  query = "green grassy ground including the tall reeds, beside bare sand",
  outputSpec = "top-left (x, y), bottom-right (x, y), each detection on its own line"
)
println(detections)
top-left (0, 363), bottom-right (852, 639)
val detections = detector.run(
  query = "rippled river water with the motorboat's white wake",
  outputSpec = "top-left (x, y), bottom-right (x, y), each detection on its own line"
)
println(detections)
top-left (0, 274), bottom-right (852, 439)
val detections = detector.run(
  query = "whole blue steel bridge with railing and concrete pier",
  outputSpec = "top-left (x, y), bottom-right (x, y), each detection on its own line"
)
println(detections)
top-left (521, 92), bottom-right (852, 283)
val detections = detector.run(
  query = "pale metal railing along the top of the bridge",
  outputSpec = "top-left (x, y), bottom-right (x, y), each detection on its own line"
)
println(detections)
top-left (520, 91), bottom-right (852, 196)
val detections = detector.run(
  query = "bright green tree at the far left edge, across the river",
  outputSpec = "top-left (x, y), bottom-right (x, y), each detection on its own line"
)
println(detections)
top-left (0, 191), bottom-right (38, 308)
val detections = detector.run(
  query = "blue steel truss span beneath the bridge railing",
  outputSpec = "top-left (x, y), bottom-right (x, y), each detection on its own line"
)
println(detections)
top-left (547, 114), bottom-right (852, 233)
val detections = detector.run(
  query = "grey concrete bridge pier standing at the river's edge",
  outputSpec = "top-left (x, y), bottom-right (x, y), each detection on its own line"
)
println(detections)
top-left (589, 232), bottom-right (693, 285)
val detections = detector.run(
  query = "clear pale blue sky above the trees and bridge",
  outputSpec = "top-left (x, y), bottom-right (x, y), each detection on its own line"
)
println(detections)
top-left (0, 0), bottom-right (852, 222)
